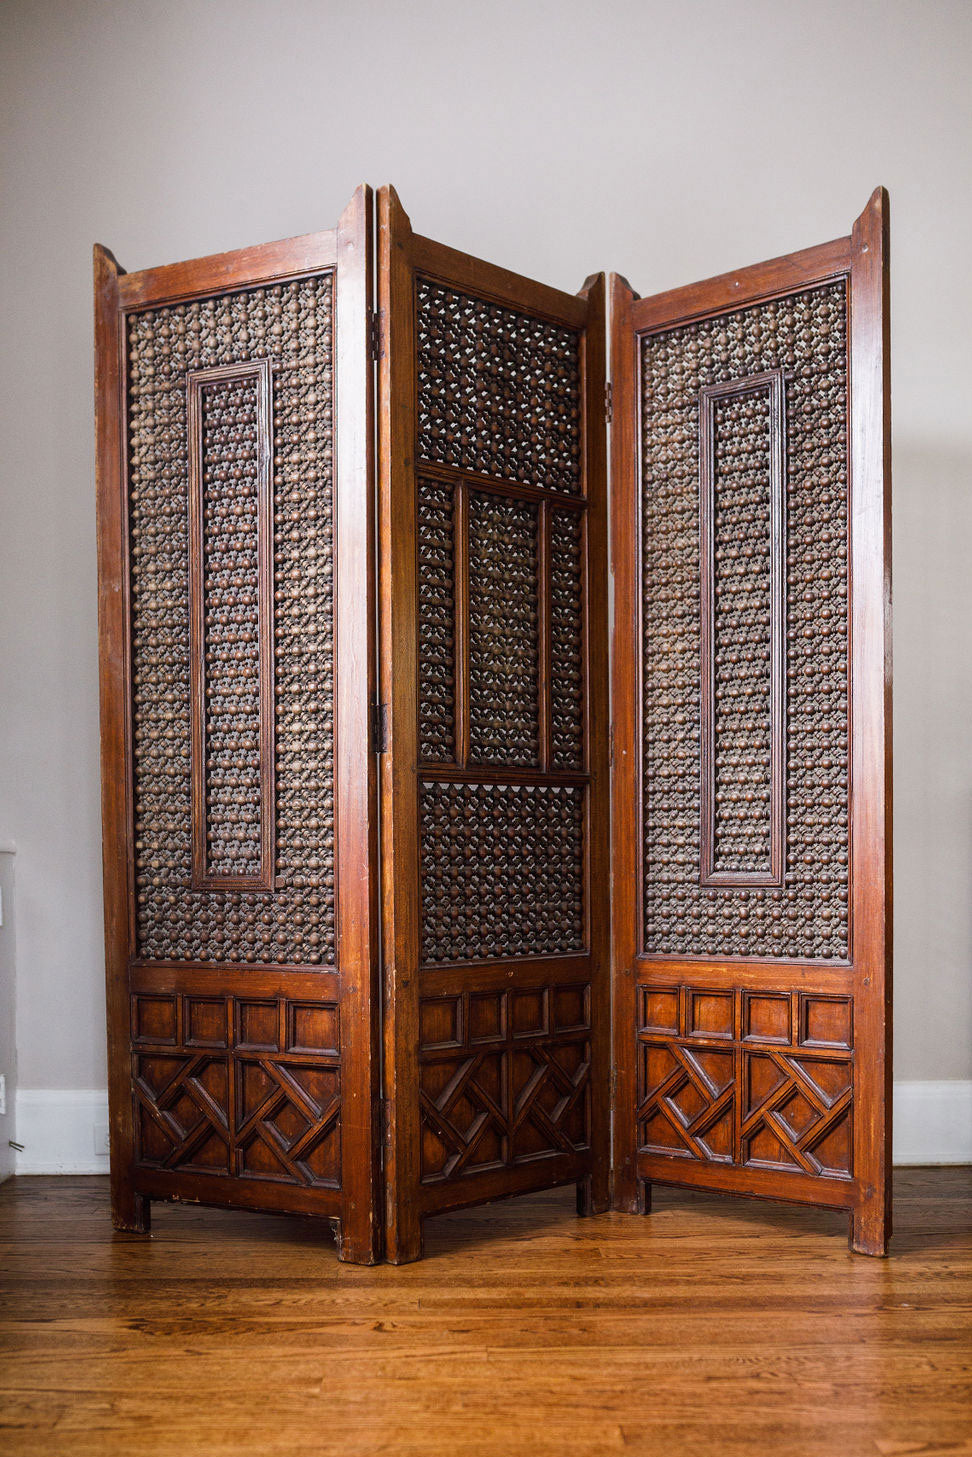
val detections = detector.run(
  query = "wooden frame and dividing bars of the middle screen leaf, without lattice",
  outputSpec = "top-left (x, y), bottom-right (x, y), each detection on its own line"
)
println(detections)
top-left (379, 188), bottom-right (609, 1263)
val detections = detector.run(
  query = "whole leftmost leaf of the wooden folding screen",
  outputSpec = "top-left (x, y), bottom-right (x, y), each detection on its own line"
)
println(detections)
top-left (95, 188), bottom-right (380, 1262)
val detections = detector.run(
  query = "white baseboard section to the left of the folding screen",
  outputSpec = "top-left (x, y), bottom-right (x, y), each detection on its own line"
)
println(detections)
top-left (16, 1088), bottom-right (108, 1174)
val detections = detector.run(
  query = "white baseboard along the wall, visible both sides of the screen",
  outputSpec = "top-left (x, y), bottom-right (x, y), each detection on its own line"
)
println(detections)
top-left (16, 1078), bottom-right (972, 1174)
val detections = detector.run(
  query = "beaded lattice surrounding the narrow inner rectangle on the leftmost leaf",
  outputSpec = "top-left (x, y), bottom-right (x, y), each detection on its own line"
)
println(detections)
top-left (128, 274), bottom-right (335, 965)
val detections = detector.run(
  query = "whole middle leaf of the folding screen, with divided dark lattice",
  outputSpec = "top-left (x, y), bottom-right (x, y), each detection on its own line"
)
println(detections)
top-left (379, 188), bottom-right (609, 1262)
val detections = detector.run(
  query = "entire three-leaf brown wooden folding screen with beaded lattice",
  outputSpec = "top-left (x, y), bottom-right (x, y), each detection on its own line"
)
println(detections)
top-left (95, 188), bottom-right (890, 1262)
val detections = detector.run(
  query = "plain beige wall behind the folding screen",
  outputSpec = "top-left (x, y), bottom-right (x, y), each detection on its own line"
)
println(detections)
top-left (0, 0), bottom-right (972, 1088)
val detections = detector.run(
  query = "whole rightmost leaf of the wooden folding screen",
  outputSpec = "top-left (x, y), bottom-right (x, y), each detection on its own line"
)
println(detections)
top-left (612, 191), bottom-right (890, 1253)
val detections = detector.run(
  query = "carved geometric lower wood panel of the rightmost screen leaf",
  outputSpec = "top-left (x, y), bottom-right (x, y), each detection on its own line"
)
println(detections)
top-left (637, 985), bottom-right (854, 1179)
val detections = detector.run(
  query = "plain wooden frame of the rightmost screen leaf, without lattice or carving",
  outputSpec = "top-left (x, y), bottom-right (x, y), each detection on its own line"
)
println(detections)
top-left (612, 188), bottom-right (892, 1254)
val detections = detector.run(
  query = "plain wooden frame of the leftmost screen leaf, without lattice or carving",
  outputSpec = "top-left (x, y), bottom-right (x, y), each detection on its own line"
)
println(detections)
top-left (95, 188), bottom-right (382, 1263)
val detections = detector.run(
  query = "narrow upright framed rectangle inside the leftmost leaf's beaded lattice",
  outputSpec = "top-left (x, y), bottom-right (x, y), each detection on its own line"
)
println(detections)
top-left (188, 360), bottom-right (274, 890)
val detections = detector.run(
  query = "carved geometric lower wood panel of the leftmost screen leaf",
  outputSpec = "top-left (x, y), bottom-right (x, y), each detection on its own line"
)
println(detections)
top-left (131, 992), bottom-right (341, 1189)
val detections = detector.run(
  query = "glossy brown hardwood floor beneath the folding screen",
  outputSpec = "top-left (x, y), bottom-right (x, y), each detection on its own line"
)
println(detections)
top-left (0, 1169), bottom-right (972, 1457)
